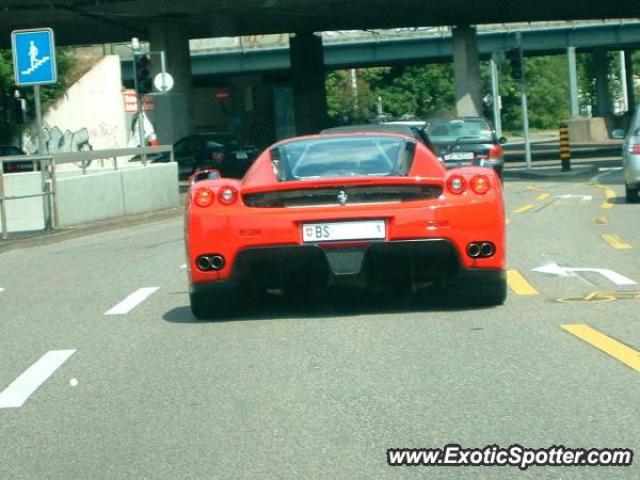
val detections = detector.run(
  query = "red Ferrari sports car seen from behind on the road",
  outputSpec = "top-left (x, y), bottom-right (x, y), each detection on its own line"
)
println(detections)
top-left (185, 132), bottom-right (506, 318)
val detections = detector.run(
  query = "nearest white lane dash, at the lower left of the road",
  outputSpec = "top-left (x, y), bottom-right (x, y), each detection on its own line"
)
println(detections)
top-left (0, 350), bottom-right (76, 408)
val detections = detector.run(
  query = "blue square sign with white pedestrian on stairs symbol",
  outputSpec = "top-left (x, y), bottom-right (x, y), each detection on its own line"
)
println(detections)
top-left (11, 28), bottom-right (58, 85)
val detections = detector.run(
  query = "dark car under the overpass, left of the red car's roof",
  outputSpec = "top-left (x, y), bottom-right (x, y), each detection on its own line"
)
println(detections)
top-left (151, 132), bottom-right (259, 179)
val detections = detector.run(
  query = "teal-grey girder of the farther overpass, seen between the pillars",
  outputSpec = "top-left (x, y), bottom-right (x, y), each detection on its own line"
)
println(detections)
top-left (121, 21), bottom-right (640, 77)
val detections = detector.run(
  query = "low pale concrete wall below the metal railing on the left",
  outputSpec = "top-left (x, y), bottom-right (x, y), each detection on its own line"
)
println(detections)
top-left (4, 162), bottom-right (179, 233)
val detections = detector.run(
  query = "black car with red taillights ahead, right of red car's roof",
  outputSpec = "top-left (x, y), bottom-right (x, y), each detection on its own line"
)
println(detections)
top-left (425, 117), bottom-right (507, 177)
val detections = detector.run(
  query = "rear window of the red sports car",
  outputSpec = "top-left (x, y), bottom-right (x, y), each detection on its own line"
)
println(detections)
top-left (271, 135), bottom-right (416, 180)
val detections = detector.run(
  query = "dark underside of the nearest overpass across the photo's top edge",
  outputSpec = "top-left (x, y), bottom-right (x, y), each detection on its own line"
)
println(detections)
top-left (0, 0), bottom-right (638, 47)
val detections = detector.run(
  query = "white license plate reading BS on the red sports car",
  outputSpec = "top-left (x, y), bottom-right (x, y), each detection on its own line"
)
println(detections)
top-left (302, 220), bottom-right (387, 243)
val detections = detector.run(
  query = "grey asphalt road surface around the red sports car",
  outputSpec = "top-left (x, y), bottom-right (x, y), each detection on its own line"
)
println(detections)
top-left (0, 166), bottom-right (640, 480)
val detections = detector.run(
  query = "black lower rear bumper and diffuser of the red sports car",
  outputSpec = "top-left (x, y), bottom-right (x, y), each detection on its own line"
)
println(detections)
top-left (190, 239), bottom-right (506, 293)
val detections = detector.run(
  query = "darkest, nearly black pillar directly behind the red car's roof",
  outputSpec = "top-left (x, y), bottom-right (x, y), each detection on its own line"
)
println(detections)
top-left (289, 32), bottom-right (327, 135)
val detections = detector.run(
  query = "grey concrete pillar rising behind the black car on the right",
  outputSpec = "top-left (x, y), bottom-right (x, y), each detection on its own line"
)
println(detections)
top-left (452, 25), bottom-right (482, 116)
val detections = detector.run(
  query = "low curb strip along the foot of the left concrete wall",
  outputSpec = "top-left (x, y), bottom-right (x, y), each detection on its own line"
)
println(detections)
top-left (0, 207), bottom-right (184, 254)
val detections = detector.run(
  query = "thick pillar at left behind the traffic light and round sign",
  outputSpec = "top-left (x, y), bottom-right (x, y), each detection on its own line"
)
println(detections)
top-left (149, 21), bottom-right (193, 144)
